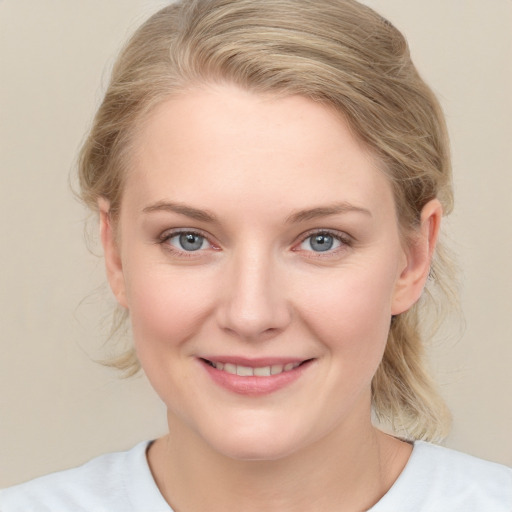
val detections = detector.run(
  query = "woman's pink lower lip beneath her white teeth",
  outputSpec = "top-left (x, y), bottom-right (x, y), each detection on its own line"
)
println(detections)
top-left (199, 359), bottom-right (312, 396)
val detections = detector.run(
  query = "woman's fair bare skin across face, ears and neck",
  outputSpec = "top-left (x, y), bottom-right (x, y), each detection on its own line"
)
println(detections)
top-left (99, 85), bottom-right (441, 512)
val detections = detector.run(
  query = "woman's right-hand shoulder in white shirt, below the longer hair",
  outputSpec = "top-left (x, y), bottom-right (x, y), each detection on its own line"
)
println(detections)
top-left (371, 441), bottom-right (512, 512)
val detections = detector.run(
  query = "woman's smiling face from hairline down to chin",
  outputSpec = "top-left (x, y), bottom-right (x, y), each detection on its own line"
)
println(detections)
top-left (100, 86), bottom-right (432, 459)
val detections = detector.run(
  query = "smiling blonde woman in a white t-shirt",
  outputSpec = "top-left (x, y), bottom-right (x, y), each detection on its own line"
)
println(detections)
top-left (0, 0), bottom-right (512, 512)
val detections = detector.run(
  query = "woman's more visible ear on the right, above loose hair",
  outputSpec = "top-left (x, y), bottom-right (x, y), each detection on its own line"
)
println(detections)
top-left (391, 199), bottom-right (443, 315)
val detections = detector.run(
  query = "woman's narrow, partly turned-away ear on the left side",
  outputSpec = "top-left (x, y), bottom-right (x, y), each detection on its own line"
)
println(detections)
top-left (98, 197), bottom-right (128, 308)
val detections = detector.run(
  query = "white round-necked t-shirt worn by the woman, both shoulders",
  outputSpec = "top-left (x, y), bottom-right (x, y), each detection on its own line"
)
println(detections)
top-left (0, 441), bottom-right (512, 512)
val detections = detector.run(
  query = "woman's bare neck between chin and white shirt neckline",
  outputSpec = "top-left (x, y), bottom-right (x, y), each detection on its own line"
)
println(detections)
top-left (148, 408), bottom-right (411, 512)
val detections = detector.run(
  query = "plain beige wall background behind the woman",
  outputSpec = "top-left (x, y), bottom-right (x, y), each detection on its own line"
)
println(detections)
top-left (0, 0), bottom-right (512, 487)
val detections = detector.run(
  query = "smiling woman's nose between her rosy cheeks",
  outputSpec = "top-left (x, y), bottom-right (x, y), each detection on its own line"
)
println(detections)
top-left (218, 250), bottom-right (292, 341)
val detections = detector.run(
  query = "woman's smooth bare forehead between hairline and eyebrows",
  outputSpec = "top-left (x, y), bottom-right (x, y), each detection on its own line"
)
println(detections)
top-left (123, 85), bottom-right (393, 219)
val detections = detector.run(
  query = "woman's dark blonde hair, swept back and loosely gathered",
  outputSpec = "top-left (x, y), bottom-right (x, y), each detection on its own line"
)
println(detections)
top-left (79, 0), bottom-right (453, 440)
